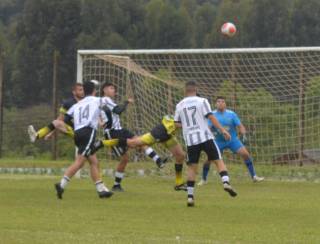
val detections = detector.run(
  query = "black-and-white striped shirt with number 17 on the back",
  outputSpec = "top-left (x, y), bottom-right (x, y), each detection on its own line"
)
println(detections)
top-left (174, 96), bottom-right (214, 146)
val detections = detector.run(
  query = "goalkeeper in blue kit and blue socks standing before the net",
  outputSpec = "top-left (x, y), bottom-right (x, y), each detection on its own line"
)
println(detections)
top-left (198, 97), bottom-right (264, 185)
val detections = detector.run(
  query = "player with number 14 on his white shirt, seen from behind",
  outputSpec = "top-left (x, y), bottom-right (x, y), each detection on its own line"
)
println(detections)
top-left (55, 81), bottom-right (112, 199)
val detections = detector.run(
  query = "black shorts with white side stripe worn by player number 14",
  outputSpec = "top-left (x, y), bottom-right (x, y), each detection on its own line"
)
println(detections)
top-left (74, 127), bottom-right (96, 157)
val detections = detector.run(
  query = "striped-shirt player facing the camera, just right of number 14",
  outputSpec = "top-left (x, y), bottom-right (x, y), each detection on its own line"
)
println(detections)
top-left (101, 82), bottom-right (166, 191)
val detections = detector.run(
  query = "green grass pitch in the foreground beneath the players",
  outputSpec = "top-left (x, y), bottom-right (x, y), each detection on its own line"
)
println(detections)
top-left (0, 175), bottom-right (320, 243)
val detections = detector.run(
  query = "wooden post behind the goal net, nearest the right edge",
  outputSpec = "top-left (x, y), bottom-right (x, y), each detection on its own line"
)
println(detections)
top-left (299, 61), bottom-right (306, 166)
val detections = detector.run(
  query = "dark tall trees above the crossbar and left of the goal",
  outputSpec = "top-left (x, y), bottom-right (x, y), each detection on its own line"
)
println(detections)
top-left (0, 0), bottom-right (320, 107)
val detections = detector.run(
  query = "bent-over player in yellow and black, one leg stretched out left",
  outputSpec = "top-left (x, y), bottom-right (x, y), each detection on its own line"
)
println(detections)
top-left (95, 115), bottom-right (187, 191)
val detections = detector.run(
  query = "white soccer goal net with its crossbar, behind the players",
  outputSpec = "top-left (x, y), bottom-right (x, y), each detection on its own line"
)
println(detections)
top-left (77, 47), bottom-right (320, 164)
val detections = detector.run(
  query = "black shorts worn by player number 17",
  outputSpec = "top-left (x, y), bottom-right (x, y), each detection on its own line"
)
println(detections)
top-left (187, 140), bottom-right (222, 164)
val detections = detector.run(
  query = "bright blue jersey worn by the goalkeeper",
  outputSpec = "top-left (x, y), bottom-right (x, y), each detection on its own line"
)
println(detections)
top-left (208, 109), bottom-right (241, 142)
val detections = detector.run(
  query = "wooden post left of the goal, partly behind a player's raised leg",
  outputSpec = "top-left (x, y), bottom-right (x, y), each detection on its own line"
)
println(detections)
top-left (51, 50), bottom-right (59, 160)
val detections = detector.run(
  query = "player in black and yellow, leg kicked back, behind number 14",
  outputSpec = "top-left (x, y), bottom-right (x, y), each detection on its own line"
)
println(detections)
top-left (28, 83), bottom-right (84, 142)
